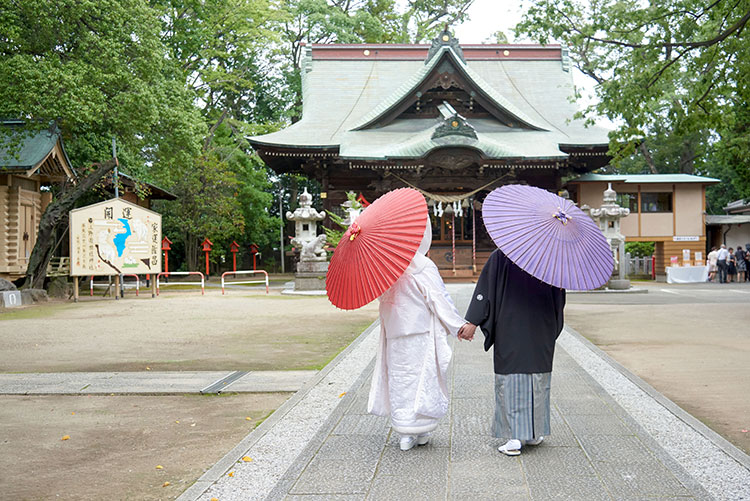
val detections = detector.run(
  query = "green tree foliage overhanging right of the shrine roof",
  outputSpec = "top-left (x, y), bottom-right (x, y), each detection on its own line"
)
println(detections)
top-left (516, 0), bottom-right (750, 193)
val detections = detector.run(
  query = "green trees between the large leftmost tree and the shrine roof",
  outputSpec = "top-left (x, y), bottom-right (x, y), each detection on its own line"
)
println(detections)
top-left (152, 0), bottom-right (285, 269)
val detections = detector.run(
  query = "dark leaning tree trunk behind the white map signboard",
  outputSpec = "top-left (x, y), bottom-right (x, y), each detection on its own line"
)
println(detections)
top-left (22, 158), bottom-right (117, 289)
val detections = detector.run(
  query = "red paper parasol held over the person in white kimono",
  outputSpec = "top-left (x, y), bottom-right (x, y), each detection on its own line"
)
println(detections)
top-left (326, 188), bottom-right (427, 310)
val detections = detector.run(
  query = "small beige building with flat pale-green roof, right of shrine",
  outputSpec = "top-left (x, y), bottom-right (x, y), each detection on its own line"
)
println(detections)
top-left (567, 174), bottom-right (721, 275)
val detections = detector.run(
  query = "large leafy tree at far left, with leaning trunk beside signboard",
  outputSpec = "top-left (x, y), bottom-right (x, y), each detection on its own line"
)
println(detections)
top-left (0, 0), bottom-right (204, 284)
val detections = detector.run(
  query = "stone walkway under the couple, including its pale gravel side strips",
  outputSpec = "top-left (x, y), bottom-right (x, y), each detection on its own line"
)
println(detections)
top-left (187, 286), bottom-right (750, 501)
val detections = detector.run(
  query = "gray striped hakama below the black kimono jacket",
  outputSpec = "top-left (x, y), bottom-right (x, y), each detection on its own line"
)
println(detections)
top-left (492, 372), bottom-right (552, 440)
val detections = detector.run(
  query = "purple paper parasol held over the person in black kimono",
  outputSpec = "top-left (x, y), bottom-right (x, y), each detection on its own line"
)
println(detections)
top-left (482, 184), bottom-right (614, 290)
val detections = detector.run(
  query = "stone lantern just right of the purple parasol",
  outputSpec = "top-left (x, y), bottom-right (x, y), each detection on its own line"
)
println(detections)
top-left (581, 183), bottom-right (630, 289)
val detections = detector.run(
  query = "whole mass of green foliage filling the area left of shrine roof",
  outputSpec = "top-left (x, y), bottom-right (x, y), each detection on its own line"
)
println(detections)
top-left (0, 0), bottom-right (473, 278)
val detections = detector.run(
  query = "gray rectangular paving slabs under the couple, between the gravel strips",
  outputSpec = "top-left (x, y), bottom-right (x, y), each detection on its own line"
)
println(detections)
top-left (271, 290), bottom-right (707, 501)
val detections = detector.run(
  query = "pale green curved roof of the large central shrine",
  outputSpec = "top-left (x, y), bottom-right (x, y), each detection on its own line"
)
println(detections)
top-left (249, 46), bottom-right (609, 160)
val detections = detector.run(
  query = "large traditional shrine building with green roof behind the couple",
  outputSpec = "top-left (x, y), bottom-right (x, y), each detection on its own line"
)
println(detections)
top-left (249, 31), bottom-right (609, 277)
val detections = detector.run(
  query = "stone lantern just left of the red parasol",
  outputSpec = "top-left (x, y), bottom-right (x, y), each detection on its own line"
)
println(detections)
top-left (286, 188), bottom-right (328, 291)
